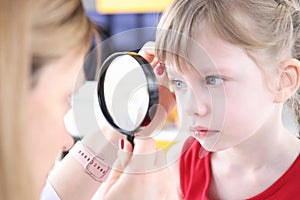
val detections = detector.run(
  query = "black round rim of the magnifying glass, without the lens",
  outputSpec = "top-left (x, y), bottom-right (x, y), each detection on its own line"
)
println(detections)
top-left (97, 52), bottom-right (159, 136)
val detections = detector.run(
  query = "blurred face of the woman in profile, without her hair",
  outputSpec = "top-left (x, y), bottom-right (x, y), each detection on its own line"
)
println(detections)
top-left (27, 52), bottom-right (84, 191)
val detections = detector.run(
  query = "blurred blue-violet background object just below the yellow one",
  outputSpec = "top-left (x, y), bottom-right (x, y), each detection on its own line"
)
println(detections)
top-left (84, 11), bottom-right (161, 80)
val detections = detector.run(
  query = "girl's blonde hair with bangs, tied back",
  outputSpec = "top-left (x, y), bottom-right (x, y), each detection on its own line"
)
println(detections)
top-left (156, 0), bottom-right (300, 133)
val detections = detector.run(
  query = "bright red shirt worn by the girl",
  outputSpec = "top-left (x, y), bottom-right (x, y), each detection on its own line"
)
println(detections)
top-left (179, 138), bottom-right (300, 200)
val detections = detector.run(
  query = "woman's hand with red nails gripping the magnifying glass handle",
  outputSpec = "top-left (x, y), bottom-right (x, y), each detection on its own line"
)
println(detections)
top-left (95, 138), bottom-right (180, 200)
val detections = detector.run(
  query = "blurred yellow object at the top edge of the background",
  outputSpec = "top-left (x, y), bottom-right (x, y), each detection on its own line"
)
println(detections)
top-left (96, 0), bottom-right (173, 14)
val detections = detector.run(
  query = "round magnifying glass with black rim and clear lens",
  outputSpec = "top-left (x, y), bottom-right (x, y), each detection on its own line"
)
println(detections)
top-left (97, 52), bottom-right (159, 145)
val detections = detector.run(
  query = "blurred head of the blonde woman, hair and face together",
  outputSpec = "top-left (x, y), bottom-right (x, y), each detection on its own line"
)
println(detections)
top-left (0, 0), bottom-right (92, 199)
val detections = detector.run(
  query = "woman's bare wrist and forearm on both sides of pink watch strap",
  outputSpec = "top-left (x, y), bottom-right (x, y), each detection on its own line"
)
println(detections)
top-left (48, 126), bottom-right (125, 200)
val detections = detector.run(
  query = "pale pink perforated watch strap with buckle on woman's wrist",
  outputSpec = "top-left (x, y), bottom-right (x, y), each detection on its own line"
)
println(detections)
top-left (70, 141), bottom-right (111, 182)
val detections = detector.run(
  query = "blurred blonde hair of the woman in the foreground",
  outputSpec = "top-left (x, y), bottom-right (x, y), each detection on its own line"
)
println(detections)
top-left (0, 0), bottom-right (92, 200)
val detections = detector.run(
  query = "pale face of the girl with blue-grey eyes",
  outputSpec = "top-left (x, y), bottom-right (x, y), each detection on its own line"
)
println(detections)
top-left (166, 31), bottom-right (276, 151)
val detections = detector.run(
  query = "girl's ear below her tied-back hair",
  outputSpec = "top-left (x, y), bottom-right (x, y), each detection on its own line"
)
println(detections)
top-left (274, 58), bottom-right (300, 103)
